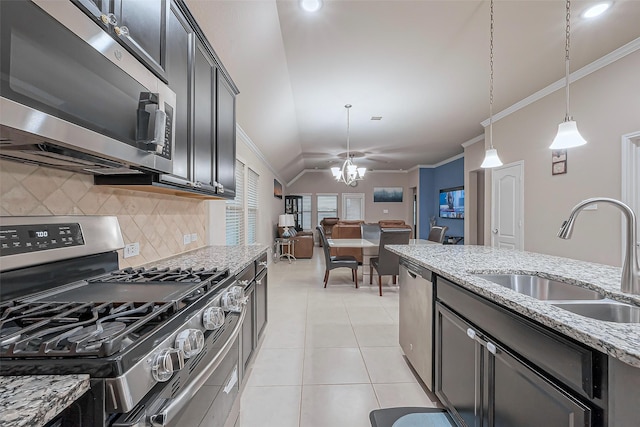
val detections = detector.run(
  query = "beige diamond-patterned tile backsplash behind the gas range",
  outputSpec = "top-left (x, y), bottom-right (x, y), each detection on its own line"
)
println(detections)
top-left (0, 160), bottom-right (207, 268)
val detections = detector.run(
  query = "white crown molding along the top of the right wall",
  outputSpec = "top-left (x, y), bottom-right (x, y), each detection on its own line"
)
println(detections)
top-left (481, 37), bottom-right (640, 127)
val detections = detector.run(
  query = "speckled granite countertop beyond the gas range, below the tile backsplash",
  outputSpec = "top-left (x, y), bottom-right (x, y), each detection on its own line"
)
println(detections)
top-left (146, 244), bottom-right (269, 274)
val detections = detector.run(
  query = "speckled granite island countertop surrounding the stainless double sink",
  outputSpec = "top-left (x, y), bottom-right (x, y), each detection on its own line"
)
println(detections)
top-left (387, 245), bottom-right (640, 368)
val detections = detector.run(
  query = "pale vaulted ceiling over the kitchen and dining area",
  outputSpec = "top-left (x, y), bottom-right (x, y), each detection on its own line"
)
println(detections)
top-left (186, 0), bottom-right (640, 181)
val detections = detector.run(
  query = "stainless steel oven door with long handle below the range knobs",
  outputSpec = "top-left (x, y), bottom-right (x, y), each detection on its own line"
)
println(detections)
top-left (110, 306), bottom-right (247, 427)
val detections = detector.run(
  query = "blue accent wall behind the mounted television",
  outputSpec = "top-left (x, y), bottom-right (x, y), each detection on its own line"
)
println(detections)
top-left (419, 157), bottom-right (466, 239)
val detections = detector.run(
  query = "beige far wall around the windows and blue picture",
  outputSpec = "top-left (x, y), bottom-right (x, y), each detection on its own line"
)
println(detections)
top-left (285, 170), bottom-right (412, 227)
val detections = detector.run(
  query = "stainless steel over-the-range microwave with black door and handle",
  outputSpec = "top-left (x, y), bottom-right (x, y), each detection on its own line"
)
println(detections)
top-left (0, 0), bottom-right (176, 174)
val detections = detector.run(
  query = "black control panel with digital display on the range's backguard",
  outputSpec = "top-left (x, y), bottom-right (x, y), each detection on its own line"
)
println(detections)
top-left (0, 223), bottom-right (84, 256)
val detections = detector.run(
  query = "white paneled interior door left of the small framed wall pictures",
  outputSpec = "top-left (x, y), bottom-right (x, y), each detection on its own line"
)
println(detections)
top-left (491, 162), bottom-right (524, 250)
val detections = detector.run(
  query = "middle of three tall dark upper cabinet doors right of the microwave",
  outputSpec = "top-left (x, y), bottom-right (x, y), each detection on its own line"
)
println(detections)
top-left (193, 42), bottom-right (215, 186)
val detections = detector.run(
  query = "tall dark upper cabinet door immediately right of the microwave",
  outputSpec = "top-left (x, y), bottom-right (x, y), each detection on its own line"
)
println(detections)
top-left (166, 4), bottom-right (194, 180)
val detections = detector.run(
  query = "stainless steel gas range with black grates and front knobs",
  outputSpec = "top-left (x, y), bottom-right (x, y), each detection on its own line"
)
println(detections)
top-left (0, 216), bottom-right (246, 426)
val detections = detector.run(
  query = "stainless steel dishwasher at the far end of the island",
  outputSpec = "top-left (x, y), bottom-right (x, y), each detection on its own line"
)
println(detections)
top-left (400, 259), bottom-right (433, 391)
